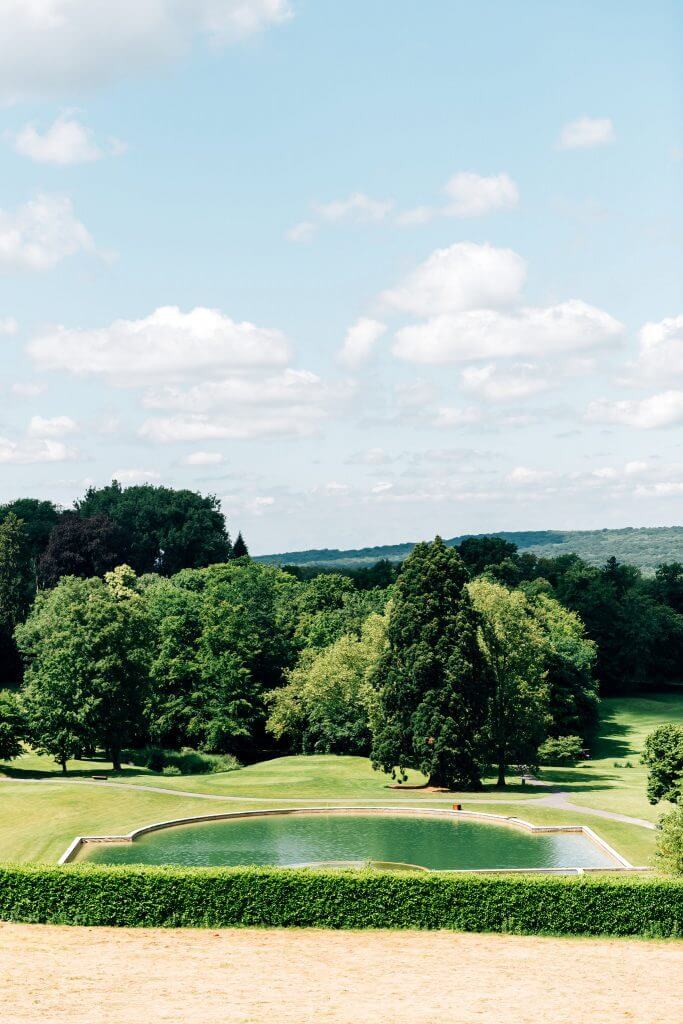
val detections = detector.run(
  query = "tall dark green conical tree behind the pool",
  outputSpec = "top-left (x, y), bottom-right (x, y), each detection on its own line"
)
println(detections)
top-left (372, 537), bottom-right (489, 788)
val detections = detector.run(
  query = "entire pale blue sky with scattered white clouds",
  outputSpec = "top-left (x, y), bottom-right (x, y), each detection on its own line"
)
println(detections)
top-left (0, 0), bottom-right (683, 552)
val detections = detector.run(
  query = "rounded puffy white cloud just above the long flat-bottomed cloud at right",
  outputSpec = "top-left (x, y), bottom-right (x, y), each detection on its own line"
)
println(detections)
top-left (382, 242), bottom-right (526, 316)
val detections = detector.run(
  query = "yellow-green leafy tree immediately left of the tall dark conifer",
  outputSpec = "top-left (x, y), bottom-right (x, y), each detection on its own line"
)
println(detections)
top-left (267, 614), bottom-right (388, 754)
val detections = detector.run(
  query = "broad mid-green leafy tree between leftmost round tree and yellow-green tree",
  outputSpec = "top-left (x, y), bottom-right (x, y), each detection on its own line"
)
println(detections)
top-left (145, 561), bottom-right (299, 753)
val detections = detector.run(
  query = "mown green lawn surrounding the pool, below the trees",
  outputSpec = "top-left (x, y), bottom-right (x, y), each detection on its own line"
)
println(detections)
top-left (0, 695), bottom-right (683, 864)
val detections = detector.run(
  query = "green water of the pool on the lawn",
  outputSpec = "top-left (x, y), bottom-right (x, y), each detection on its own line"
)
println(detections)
top-left (80, 813), bottom-right (614, 869)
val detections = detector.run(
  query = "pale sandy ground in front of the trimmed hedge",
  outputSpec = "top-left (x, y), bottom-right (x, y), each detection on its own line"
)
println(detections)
top-left (0, 925), bottom-right (683, 1024)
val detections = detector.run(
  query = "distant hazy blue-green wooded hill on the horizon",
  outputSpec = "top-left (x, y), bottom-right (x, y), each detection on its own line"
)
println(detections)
top-left (256, 526), bottom-right (683, 574)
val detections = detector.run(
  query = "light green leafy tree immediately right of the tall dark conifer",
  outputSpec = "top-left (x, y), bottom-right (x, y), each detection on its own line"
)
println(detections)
top-left (468, 577), bottom-right (549, 786)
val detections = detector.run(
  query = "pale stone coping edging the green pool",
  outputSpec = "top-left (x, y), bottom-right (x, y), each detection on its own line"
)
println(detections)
top-left (57, 807), bottom-right (650, 874)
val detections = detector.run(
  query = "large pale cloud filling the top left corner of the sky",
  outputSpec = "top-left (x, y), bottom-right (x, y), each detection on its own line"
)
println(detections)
top-left (0, 0), bottom-right (292, 99)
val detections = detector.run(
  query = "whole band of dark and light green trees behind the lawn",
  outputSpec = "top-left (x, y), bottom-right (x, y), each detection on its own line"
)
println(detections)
top-left (0, 483), bottom-right (683, 788)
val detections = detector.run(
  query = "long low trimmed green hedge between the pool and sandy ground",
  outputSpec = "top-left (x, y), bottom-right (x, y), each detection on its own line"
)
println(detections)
top-left (0, 864), bottom-right (683, 937)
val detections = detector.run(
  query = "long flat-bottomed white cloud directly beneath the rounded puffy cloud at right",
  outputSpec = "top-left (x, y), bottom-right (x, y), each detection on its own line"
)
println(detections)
top-left (393, 299), bottom-right (624, 364)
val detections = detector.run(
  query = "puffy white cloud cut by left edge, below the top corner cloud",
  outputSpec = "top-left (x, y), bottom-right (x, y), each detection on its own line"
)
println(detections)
top-left (0, 194), bottom-right (94, 270)
